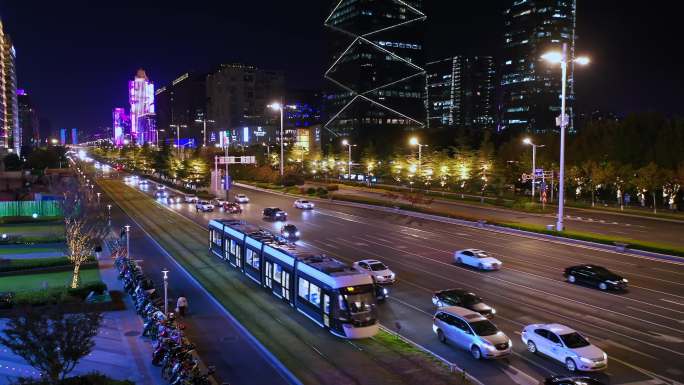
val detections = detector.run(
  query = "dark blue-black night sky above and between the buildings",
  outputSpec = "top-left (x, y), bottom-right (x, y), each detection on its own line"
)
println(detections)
top-left (0, 0), bottom-right (684, 135)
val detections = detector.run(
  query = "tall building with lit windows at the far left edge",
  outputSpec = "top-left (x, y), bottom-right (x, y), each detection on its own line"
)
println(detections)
top-left (0, 20), bottom-right (22, 154)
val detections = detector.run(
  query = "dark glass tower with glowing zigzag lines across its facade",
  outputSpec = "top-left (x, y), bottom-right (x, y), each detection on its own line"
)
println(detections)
top-left (324, 0), bottom-right (426, 153)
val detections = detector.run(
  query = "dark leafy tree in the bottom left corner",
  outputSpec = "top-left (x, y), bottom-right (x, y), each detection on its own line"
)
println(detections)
top-left (0, 309), bottom-right (102, 384)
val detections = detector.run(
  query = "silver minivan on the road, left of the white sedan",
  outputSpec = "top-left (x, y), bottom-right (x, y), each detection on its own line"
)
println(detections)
top-left (432, 306), bottom-right (513, 360)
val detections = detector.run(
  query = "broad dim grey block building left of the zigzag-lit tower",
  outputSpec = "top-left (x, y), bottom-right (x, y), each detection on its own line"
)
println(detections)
top-left (206, 64), bottom-right (285, 144)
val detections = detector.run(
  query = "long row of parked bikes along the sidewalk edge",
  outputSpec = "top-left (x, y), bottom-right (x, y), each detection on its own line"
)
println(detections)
top-left (113, 243), bottom-right (213, 385)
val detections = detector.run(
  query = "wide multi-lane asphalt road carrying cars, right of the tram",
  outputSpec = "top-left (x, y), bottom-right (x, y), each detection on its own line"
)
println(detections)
top-left (127, 177), bottom-right (684, 385)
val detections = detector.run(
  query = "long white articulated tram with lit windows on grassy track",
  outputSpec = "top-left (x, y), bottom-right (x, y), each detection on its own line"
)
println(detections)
top-left (209, 219), bottom-right (379, 339)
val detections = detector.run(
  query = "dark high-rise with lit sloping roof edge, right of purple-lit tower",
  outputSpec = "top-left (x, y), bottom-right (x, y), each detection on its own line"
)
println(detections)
top-left (155, 72), bottom-right (207, 144)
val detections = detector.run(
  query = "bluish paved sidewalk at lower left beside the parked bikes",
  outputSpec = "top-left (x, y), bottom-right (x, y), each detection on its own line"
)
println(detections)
top-left (0, 238), bottom-right (167, 385)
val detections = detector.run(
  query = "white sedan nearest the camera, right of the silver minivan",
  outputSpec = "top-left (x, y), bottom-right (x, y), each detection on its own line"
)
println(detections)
top-left (520, 324), bottom-right (608, 372)
